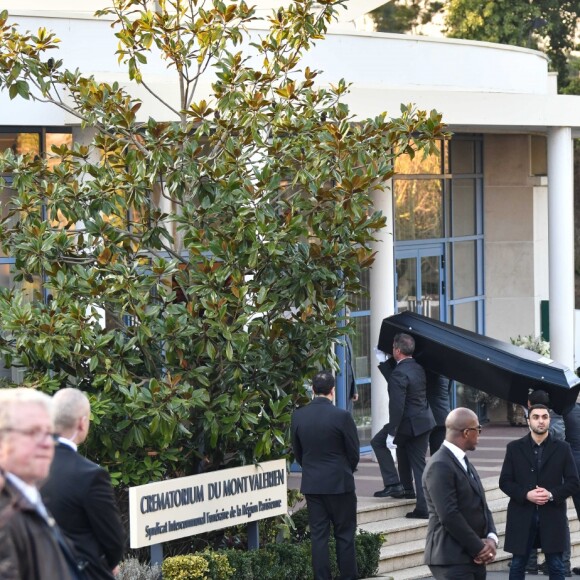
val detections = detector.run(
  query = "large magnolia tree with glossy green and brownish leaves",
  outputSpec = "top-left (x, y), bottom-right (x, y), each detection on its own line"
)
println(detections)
top-left (0, 0), bottom-right (445, 484)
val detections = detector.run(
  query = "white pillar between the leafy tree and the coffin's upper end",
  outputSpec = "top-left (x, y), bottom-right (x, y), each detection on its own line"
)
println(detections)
top-left (370, 182), bottom-right (395, 444)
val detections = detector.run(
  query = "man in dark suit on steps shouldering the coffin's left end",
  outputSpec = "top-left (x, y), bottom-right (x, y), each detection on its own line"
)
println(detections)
top-left (371, 333), bottom-right (435, 519)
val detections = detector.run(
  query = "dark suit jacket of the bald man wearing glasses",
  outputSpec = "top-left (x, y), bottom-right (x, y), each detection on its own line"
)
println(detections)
top-left (423, 445), bottom-right (496, 566)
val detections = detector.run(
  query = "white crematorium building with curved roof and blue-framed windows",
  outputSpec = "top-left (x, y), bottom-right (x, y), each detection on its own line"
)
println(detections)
top-left (0, 0), bottom-right (580, 441)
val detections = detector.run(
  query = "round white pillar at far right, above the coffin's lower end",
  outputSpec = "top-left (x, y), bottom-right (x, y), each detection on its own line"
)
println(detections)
top-left (548, 127), bottom-right (574, 369)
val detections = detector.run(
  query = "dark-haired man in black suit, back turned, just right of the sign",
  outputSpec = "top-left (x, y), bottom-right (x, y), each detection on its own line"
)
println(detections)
top-left (291, 371), bottom-right (360, 580)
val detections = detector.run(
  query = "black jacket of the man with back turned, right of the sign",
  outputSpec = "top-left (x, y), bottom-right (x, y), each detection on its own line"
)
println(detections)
top-left (291, 397), bottom-right (360, 494)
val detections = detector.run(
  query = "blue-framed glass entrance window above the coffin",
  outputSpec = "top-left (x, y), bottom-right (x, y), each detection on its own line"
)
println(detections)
top-left (393, 134), bottom-right (485, 409)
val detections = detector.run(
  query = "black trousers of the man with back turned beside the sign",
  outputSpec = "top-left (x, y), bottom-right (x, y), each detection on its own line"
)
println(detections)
top-left (306, 491), bottom-right (358, 580)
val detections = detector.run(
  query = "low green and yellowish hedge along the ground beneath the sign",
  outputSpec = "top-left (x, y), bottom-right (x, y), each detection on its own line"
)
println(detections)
top-left (163, 530), bottom-right (384, 580)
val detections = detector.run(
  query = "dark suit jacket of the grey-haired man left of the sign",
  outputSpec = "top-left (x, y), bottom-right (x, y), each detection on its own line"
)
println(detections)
top-left (40, 443), bottom-right (125, 580)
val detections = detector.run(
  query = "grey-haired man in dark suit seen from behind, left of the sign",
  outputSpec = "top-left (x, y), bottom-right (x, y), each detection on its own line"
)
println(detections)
top-left (41, 389), bottom-right (125, 580)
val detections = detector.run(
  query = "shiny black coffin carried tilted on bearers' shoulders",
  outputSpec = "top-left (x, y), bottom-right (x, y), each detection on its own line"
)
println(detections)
top-left (378, 312), bottom-right (580, 413)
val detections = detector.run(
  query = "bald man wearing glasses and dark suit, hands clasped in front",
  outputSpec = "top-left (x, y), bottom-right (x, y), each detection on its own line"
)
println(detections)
top-left (423, 407), bottom-right (498, 580)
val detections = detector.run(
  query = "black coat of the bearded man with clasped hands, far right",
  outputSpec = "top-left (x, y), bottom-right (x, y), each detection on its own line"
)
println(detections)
top-left (499, 434), bottom-right (579, 555)
